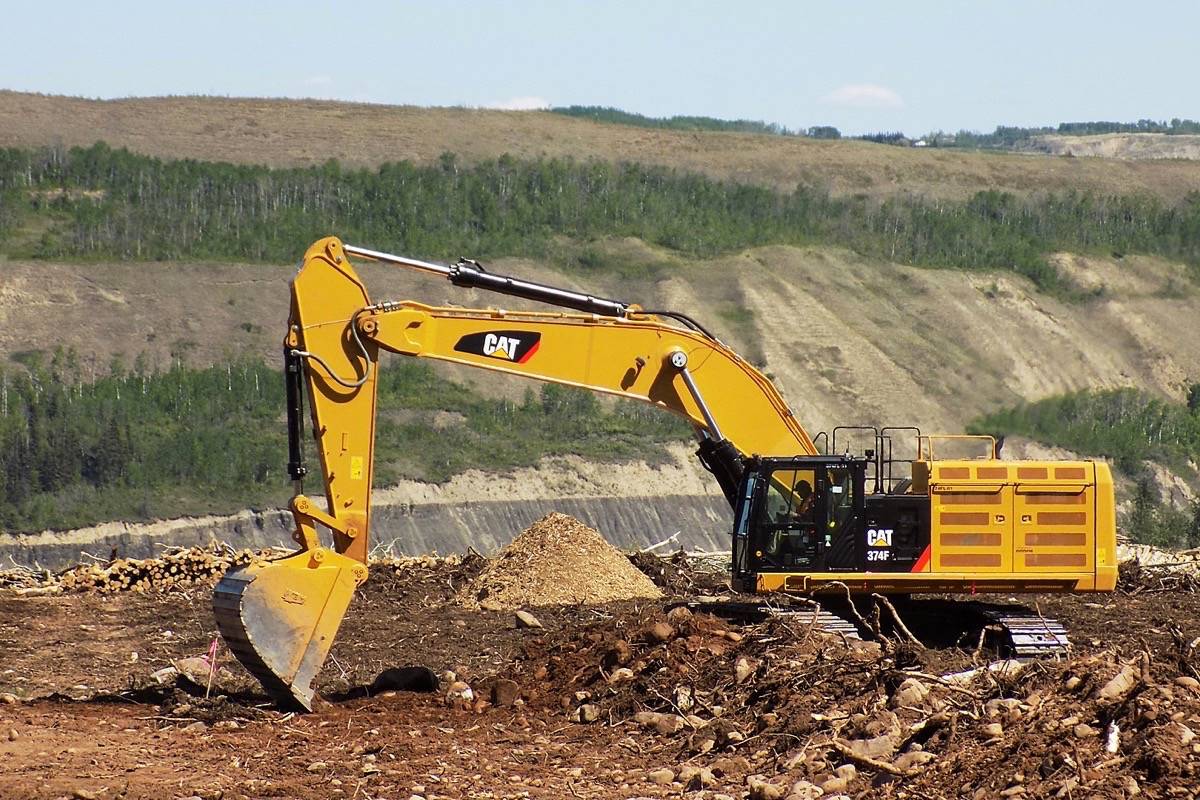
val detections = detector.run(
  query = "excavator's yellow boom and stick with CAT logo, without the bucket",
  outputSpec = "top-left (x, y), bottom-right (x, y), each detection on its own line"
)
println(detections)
top-left (288, 239), bottom-right (816, 561)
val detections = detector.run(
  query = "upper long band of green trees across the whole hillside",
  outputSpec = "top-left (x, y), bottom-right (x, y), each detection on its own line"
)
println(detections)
top-left (0, 144), bottom-right (1200, 290)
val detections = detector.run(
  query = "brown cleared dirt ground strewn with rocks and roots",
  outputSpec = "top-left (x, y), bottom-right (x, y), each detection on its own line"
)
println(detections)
top-left (0, 559), bottom-right (1200, 800)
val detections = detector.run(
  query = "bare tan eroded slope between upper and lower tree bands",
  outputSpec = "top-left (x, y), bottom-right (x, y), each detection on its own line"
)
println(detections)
top-left (0, 242), bottom-right (1200, 441)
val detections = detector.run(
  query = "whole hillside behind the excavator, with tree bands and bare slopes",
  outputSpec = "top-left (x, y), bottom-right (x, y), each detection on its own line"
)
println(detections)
top-left (0, 100), bottom-right (1200, 541)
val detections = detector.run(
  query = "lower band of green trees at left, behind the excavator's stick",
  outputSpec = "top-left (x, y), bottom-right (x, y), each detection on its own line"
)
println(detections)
top-left (0, 351), bottom-right (689, 531)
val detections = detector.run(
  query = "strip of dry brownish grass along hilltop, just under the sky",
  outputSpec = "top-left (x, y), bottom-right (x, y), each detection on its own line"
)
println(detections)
top-left (7, 91), bottom-right (1200, 199)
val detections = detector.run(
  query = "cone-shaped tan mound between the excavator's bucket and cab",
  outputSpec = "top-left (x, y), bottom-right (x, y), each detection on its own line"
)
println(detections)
top-left (460, 512), bottom-right (662, 608)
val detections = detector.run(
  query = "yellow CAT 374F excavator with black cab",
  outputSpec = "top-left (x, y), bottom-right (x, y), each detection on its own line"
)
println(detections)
top-left (214, 237), bottom-right (1117, 709)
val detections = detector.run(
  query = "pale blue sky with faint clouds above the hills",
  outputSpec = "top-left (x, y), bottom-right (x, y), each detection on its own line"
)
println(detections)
top-left (0, 0), bottom-right (1200, 134)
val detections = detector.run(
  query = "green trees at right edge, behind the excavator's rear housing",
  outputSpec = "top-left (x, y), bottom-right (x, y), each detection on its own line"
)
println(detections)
top-left (970, 384), bottom-right (1200, 547)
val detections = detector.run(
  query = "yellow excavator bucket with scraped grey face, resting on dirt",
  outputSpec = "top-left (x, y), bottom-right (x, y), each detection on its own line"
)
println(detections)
top-left (212, 547), bottom-right (366, 711)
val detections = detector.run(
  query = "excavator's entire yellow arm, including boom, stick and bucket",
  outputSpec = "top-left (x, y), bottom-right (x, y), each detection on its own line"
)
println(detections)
top-left (214, 237), bottom-right (816, 709)
